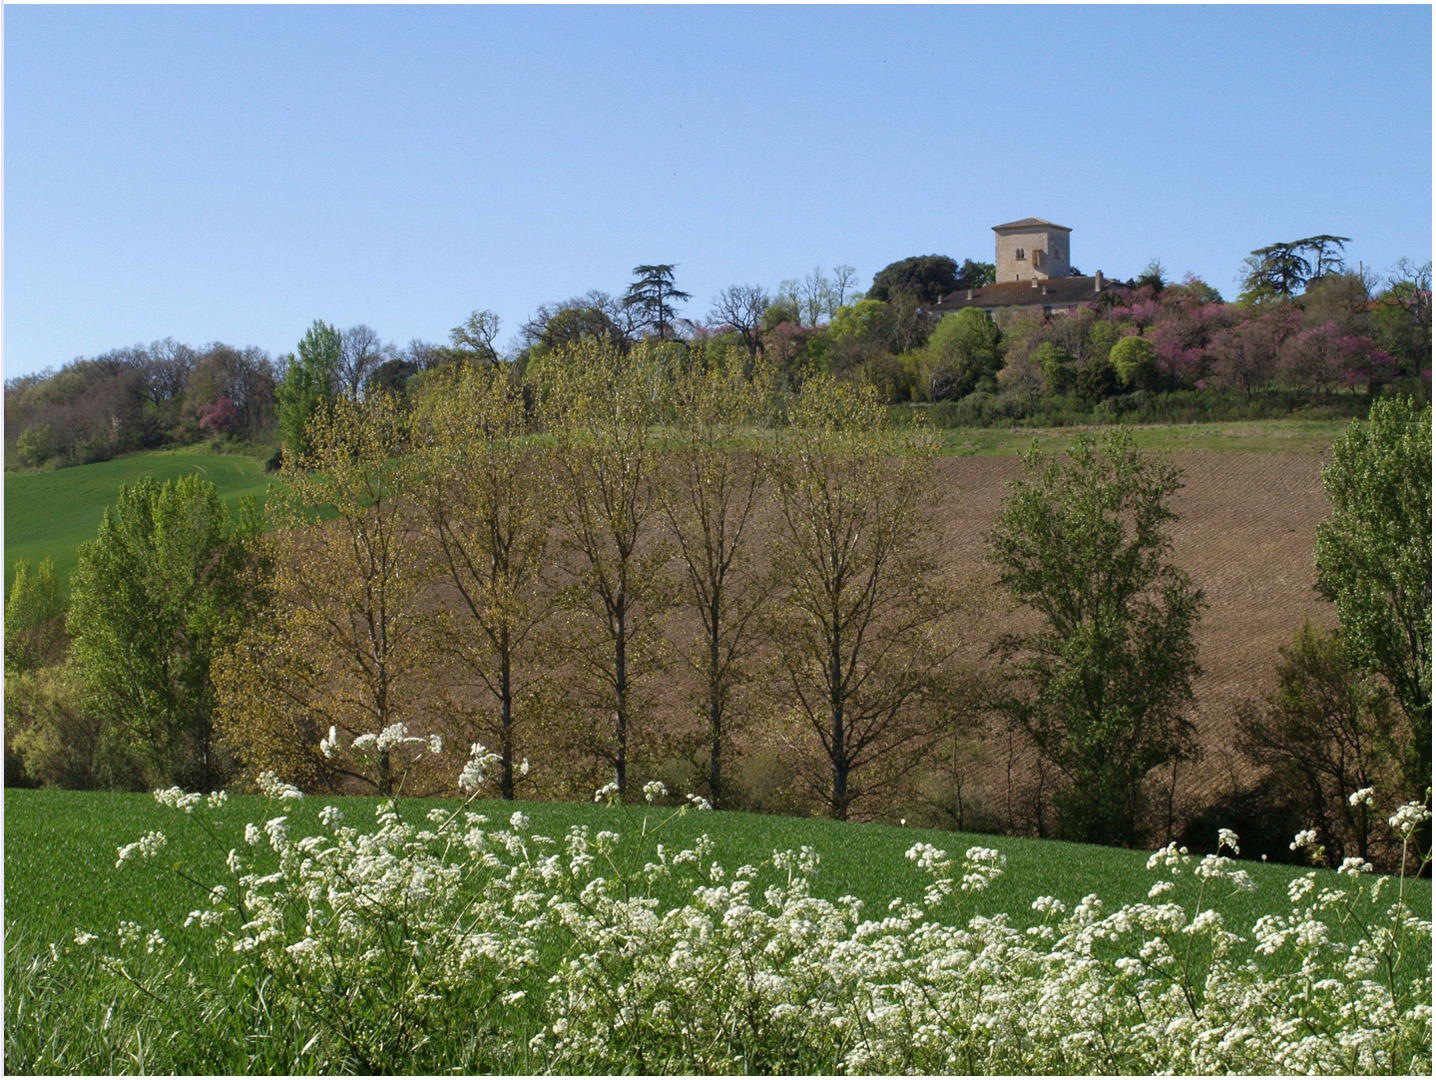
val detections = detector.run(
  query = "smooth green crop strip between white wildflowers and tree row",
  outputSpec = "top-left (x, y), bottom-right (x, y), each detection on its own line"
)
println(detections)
top-left (4, 790), bottom-right (1430, 959)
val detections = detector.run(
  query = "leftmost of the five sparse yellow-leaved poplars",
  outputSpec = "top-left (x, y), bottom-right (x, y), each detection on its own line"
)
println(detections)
top-left (218, 394), bottom-right (438, 796)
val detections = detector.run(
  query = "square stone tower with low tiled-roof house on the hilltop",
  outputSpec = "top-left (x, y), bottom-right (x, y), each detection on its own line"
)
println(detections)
top-left (932, 217), bottom-right (1124, 317)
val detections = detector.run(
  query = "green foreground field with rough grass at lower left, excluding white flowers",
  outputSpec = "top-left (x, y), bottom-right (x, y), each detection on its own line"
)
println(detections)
top-left (4, 790), bottom-right (1430, 1073)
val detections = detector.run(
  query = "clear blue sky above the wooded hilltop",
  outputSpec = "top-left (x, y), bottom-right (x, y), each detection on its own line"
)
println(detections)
top-left (4, 6), bottom-right (1432, 378)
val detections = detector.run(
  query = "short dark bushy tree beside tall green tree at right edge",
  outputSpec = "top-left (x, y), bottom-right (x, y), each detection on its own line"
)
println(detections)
top-left (1238, 623), bottom-right (1402, 866)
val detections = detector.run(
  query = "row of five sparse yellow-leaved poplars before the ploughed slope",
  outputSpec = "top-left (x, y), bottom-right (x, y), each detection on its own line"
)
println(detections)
top-left (214, 339), bottom-right (961, 819)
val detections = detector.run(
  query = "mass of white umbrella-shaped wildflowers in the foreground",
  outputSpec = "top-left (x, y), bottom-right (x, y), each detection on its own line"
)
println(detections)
top-left (75, 769), bottom-right (1432, 1073)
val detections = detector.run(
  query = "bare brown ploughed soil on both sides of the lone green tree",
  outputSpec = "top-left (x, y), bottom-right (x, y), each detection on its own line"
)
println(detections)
top-left (938, 450), bottom-right (1335, 817)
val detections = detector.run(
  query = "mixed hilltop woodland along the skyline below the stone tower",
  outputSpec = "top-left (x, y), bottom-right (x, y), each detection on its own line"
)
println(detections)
top-left (6, 248), bottom-right (1432, 467)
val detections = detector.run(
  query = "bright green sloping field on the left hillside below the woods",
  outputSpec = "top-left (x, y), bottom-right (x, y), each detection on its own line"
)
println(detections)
top-left (4, 450), bottom-right (269, 595)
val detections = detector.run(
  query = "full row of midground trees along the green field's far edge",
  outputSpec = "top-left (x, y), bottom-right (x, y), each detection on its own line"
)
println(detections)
top-left (6, 336), bottom-right (1430, 857)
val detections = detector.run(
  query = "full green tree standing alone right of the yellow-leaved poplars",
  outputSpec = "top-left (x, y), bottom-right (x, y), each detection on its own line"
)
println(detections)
top-left (988, 431), bottom-right (1202, 844)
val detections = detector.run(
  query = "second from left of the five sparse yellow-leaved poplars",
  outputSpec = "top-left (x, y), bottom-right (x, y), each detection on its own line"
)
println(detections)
top-left (416, 368), bottom-right (556, 799)
